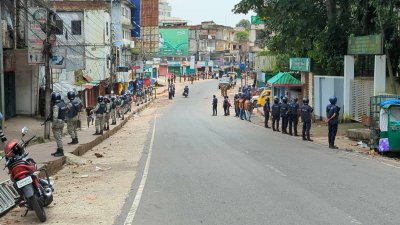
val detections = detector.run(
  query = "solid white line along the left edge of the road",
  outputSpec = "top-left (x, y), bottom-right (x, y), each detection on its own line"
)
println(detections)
top-left (124, 113), bottom-right (157, 225)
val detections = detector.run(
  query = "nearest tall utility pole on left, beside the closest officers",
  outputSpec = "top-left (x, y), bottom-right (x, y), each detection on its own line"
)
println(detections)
top-left (44, 9), bottom-right (52, 139)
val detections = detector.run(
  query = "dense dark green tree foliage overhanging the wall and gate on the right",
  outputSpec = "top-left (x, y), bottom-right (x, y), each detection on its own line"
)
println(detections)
top-left (232, 0), bottom-right (400, 81)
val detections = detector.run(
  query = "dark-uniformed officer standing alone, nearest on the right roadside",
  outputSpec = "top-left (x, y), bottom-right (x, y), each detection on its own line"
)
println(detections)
top-left (326, 96), bottom-right (340, 149)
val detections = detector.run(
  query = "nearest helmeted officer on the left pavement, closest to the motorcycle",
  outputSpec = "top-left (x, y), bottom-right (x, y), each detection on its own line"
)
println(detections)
top-left (50, 92), bottom-right (67, 157)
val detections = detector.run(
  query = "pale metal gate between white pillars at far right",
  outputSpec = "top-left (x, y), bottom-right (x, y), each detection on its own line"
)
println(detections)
top-left (351, 79), bottom-right (374, 124)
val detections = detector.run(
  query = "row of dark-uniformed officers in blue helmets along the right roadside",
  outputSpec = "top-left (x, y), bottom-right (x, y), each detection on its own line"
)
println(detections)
top-left (263, 96), bottom-right (340, 149)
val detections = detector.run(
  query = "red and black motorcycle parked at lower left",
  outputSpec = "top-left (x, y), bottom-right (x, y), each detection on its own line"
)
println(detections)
top-left (0, 127), bottom-right (54, 222)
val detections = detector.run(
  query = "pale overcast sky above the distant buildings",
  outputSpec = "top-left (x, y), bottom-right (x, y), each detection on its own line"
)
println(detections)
top-left (169, 0), bottom-right (254, 27)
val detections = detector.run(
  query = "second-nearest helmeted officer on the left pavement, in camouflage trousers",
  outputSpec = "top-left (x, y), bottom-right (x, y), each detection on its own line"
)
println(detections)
top-left (66, 91), bottom-right (80, 145)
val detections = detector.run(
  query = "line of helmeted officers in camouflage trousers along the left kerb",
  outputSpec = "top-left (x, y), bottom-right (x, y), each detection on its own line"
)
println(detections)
top-left (45, 91), bottom-right (133, 157)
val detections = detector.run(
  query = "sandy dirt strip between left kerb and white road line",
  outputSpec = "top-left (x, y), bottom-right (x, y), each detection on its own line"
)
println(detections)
top-left (0, 103), bottom-right (160, 225)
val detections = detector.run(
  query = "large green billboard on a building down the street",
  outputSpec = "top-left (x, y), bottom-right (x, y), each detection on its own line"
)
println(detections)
top-left (159, 29), bottom-right (189, 56)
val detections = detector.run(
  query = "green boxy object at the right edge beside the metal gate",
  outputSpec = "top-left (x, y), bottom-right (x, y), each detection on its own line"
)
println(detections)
top-left (379, 100), bottom-right (400, 152)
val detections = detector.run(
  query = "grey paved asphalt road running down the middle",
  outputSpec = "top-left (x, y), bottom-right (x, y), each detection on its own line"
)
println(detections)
top-left (116, 81), bottom-right (400, 225)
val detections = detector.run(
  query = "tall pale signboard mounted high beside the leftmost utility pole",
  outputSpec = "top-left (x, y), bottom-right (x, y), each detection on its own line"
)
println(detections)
top-left (28, 8), bottom-right (47, 64)
